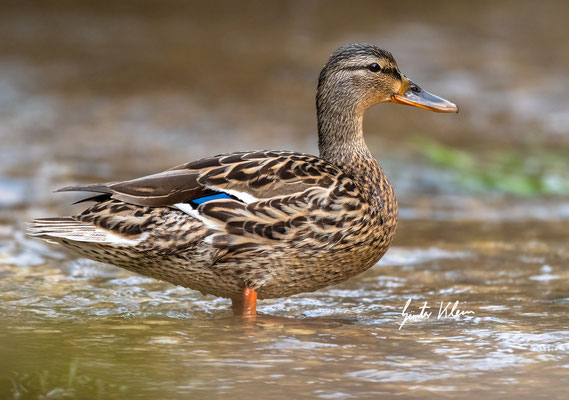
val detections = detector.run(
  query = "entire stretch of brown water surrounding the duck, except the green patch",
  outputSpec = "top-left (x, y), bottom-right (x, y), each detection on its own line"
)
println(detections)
top-left (0, 1), bottom-right (569, 399)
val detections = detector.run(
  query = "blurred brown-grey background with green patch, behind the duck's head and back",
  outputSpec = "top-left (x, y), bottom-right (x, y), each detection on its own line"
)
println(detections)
top-left (0, 0), bottom-right (569, 216)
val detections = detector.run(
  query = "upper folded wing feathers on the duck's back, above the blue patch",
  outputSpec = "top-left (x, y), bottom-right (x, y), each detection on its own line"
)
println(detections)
top-left (59, 151), bottom-right (342, 207)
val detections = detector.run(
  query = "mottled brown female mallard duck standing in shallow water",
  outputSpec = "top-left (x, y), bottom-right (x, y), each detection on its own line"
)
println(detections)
top-left (28, 44), bottom-right (458, 315)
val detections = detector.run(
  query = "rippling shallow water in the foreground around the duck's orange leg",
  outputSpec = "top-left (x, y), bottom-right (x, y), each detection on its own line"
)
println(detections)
top-left (0, 216), bottom-right (569, 399)
